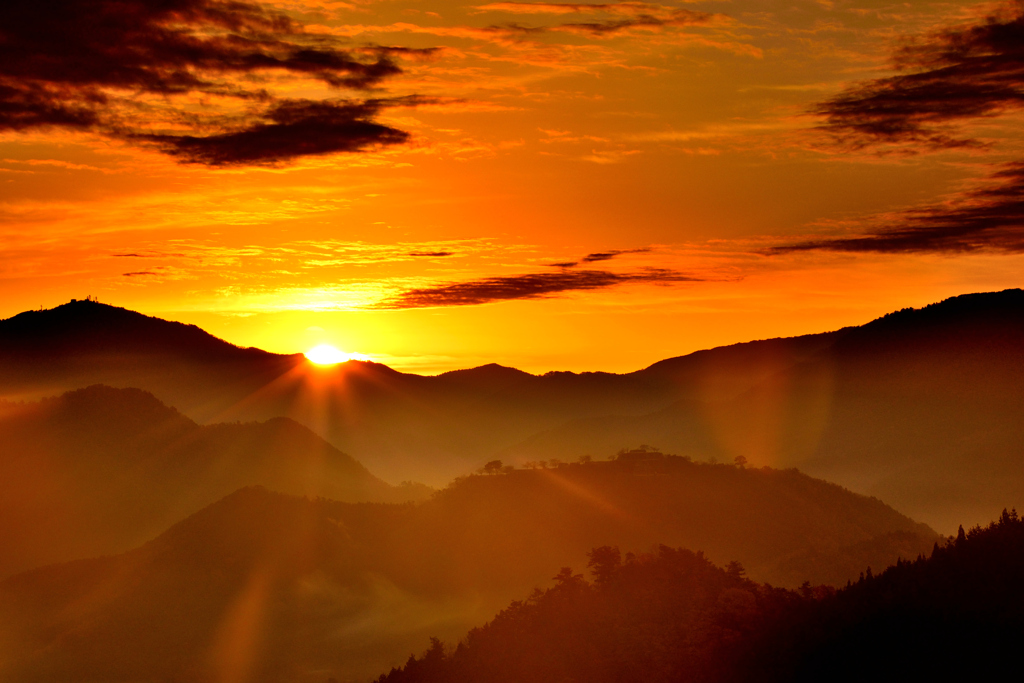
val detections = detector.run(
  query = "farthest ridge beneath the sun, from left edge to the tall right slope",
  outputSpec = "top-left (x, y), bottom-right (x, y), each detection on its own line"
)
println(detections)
top-left (0, 301), bottom-right (847, 484)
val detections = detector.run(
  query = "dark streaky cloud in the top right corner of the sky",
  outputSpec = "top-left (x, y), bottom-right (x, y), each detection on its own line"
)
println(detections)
top-left (814, 0), bottom-right (1024, 148)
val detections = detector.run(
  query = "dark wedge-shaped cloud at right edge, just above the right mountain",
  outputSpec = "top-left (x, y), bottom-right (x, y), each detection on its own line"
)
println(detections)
top-left (770, 163), bottom-right (1024, 253)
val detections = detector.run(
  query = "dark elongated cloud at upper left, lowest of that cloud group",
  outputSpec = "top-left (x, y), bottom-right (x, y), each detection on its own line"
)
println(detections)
top-left (137, 100), bottom-right (409, 166)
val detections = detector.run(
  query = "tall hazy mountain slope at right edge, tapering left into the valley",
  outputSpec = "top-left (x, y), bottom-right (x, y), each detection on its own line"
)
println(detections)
top-left (502, 290), bottom-right (1024, 532)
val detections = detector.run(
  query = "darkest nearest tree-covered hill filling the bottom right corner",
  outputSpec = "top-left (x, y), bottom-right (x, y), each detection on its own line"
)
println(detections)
top-left (378, 511), bottom-right (1024, 683)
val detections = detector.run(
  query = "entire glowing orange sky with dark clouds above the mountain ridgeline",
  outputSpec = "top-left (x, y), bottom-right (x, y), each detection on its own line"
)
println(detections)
top-left (0, 0), bottom-right (1024, 373)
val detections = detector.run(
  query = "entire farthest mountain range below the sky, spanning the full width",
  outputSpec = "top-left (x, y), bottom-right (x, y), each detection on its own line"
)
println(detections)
top-left (0, 290), bottom-right (1024, 532)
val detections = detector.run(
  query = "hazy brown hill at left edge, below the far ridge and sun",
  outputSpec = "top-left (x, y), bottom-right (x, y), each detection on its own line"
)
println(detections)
top-left (0, 386), bottom-right (427, 577)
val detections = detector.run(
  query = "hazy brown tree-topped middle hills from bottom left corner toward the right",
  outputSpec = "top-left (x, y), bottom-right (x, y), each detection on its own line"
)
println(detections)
top-left (0, 454), bottom-right (937, 683)
